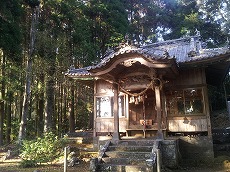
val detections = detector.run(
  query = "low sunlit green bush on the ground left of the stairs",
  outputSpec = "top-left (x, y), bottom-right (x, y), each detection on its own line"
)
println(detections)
top-left (20, 132), bottom-right (66, 167)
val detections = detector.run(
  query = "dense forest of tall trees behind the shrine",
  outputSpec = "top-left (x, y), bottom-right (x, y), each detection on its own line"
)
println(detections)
top-left (0, 0), bottom-right (230, 146)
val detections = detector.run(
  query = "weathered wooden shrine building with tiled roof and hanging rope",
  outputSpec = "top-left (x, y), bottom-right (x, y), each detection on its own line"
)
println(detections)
top-left (66, 35), bottom-right (230, 142)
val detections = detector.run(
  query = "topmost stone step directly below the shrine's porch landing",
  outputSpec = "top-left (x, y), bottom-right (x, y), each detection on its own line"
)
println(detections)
top-left (108, 145), bottom-right (153, 152)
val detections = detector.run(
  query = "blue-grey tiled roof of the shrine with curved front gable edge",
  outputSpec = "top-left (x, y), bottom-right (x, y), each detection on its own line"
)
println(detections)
top-left (66, 35), bottom-right (230, 77)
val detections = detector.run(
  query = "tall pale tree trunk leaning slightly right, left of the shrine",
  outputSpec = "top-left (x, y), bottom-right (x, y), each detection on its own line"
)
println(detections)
top-left (18, 7), bottom-right (39, 144)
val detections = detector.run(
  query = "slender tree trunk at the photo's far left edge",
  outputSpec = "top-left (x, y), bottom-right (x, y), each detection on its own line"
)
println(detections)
top-left (0, 51), bottom-right (5, 146)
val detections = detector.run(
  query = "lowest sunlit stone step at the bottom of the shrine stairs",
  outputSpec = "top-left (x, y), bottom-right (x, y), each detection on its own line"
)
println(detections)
top-left (97, 164), bottom-right (153, 172)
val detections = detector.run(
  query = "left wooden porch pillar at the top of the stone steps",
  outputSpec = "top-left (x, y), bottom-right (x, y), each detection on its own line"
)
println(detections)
top-left (113, 84), bottom-right (120, 140)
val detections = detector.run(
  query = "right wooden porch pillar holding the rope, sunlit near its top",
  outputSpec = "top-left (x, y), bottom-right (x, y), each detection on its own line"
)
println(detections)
top-left (155, 86), bottom-right (163, 139)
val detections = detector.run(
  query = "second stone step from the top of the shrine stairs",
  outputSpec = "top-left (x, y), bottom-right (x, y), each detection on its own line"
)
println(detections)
top-left (105, 151), bottom-right (151, 159)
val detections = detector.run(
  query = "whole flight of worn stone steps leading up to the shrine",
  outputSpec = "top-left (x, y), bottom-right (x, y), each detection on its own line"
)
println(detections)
top-left (95, 140), bottom-right (158, 172)
